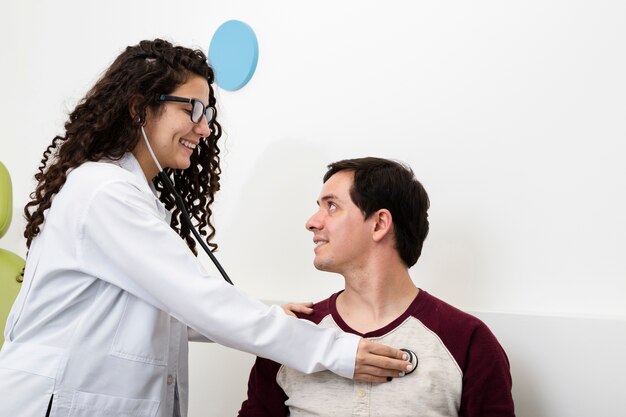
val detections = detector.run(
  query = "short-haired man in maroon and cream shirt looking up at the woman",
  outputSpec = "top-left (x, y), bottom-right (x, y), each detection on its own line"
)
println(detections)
top-left (239, 158), bottom-right (514, 417)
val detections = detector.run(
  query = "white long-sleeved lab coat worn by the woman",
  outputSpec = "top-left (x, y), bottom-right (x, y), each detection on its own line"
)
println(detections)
top-left (0, 153), bottom-right (359, 417)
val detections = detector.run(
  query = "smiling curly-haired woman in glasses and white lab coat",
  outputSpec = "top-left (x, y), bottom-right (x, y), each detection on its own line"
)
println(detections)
top-left (0, 39), bottom-right (409, 417)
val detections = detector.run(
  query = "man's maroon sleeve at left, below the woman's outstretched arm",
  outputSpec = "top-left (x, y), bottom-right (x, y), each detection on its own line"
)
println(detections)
top-left (238, 358), bottom-right (289, 417)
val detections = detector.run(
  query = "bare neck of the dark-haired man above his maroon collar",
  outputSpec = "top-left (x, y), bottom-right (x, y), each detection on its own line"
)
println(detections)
top-left (337, 265), bottom-right (419, 334)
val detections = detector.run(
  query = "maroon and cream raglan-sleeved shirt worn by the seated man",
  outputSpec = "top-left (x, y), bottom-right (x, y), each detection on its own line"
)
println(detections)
top-left (239, 290), bottom-right (515, 417)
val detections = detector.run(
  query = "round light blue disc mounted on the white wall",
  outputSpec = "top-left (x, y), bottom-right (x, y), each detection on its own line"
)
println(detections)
top-left (209, 20), bottom-right (259, 91)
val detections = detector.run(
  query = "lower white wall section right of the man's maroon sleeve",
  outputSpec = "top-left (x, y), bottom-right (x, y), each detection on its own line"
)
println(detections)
top-left (472, 313), bottom-right (626, 417)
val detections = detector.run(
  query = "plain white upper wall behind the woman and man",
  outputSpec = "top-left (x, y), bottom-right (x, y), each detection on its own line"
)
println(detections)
top-left (0, 0), bottom-right (626, 417)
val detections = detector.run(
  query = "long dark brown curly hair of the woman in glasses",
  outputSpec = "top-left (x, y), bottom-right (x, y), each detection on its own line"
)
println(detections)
top-left (24, 39), bottom-right (222, 255)
